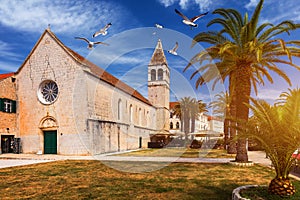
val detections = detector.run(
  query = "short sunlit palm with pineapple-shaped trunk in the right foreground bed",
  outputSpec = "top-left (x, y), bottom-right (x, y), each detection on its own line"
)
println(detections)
top-left (243, 89), bottom-right (300, 196)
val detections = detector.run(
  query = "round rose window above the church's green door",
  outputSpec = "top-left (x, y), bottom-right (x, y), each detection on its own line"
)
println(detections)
top-left (38, 80), bottom-right (58, 104)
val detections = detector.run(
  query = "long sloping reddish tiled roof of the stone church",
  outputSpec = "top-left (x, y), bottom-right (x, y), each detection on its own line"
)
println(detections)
top-left (16, 29), bottom-right (152, 105)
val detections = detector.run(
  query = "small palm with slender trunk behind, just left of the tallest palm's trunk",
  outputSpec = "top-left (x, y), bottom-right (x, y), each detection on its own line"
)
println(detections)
top-left (209, 91), bottom-right (233, 150)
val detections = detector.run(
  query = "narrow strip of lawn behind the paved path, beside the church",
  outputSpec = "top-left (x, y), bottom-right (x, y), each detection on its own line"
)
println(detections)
top-left (115, 148), bottom-right (235, 159)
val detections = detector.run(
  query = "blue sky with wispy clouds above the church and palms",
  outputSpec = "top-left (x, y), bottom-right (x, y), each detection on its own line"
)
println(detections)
top-left (0, 0), bottom-right (300, 102)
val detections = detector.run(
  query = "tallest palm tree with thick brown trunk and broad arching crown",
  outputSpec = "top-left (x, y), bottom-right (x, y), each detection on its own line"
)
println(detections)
top-left (185, 0), bottom-right (300, 162)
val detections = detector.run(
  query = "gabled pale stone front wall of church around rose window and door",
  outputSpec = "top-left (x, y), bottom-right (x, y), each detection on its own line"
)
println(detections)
top-left (16, 32), bottom-right (89, 155)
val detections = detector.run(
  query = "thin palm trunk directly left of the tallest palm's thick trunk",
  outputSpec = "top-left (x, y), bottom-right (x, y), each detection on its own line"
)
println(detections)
top-left (227, 72), bottom-right (236, 154)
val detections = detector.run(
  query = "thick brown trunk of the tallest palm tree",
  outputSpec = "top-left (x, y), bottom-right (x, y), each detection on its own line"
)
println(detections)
top-left (235, 63), bottom-right (251, 162)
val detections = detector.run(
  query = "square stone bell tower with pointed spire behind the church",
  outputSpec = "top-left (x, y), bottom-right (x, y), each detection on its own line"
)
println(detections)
top-left (148, 39), bottom-right (170, 134)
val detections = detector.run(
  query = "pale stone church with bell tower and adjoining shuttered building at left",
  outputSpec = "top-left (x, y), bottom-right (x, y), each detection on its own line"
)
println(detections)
top-left (0, 29), bottom-right (170, 155)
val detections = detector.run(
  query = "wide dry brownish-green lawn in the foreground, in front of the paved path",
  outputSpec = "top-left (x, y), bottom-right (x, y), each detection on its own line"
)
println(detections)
top-left (0, 160), bottom-right (300, 200)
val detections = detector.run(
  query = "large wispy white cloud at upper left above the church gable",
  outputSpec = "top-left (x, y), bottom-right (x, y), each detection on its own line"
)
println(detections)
top-left (0, 0), bottom-right (121, 33)
